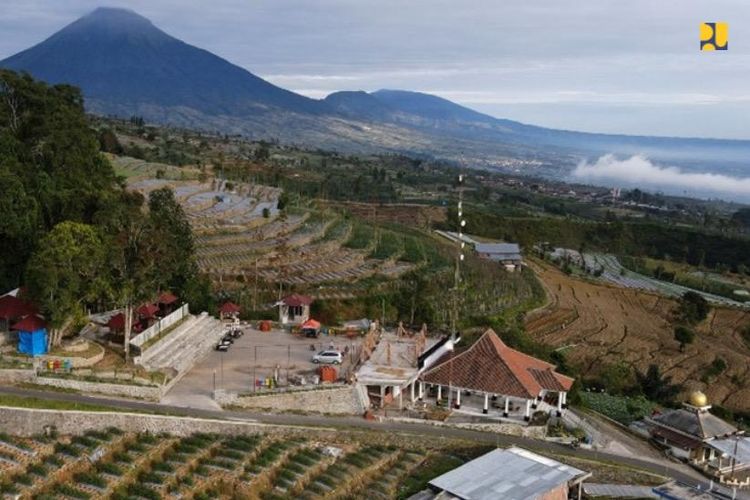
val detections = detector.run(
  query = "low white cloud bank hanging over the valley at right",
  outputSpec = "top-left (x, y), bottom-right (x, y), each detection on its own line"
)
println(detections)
top-left (572, 154), bottom-right (750, 200)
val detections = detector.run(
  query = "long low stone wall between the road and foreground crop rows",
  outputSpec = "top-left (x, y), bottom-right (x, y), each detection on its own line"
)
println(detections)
top-left (0, 407), bottom-right (304, 436)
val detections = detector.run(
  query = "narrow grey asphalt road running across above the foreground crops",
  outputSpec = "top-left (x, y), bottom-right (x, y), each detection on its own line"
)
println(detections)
top-left (0, 387), bottom-right (750, 500)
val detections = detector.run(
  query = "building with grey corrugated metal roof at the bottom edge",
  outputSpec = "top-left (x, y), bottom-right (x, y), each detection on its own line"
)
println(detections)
top-left (420, 446), bottom-right (591, 500)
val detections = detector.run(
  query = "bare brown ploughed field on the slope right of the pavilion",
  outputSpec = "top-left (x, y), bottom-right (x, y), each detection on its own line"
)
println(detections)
top-left (526, 263), bottom-right (750, 410)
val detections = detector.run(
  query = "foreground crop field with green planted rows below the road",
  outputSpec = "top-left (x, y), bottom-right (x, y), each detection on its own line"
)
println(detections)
top-left (0, 429), bottom-right (434, 500)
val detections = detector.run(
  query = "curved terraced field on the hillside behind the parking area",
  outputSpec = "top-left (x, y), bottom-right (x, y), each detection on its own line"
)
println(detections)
top-left (130, 178), bottom-right (446, 298)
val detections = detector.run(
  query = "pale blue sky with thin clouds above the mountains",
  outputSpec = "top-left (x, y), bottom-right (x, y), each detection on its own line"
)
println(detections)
top-left (0, 0), bottom-right (750, 139)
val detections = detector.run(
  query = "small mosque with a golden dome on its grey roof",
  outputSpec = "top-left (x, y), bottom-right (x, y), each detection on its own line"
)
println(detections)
top-left (645, 391), bottom-right (750, 486)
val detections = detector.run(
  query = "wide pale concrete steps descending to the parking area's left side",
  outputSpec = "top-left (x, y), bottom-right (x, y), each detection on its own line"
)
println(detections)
top-left (140, 312), bottom-right (224, 373)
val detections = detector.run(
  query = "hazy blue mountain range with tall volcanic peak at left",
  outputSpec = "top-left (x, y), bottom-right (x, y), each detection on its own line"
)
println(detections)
top-left (0, 8), bottom-right (750, 182)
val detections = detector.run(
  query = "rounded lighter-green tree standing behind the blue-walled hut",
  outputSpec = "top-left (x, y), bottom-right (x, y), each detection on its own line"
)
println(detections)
top-left (26, 222), bottom-right (106, 348)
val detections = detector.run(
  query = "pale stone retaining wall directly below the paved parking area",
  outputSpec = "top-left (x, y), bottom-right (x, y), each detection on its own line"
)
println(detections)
top-left (214, 385), bottom-right (365, 415)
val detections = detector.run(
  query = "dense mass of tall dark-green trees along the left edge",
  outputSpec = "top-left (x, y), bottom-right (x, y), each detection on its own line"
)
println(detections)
top-left (0, 70), bottom-right (210, 349)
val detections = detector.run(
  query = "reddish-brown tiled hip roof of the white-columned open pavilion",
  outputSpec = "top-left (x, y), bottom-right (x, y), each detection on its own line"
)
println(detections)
top-left (421, 329), bottom-right (573, 399)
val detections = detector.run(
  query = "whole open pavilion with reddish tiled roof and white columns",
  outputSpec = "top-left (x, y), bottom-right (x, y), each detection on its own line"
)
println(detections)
top-left (419, 329), bottom-right (574, 421)
